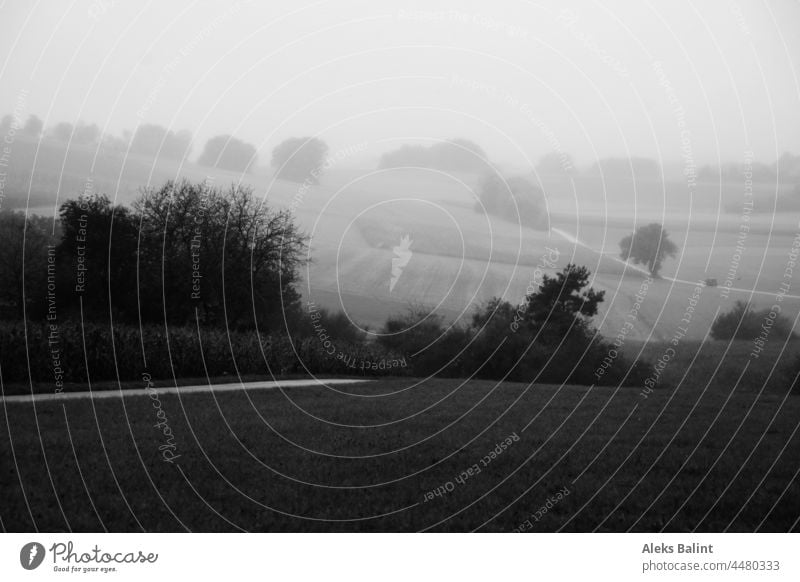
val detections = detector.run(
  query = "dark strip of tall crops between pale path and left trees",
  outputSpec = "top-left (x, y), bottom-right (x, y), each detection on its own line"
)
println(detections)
top-left (0, 320), bottom-right (404, 392)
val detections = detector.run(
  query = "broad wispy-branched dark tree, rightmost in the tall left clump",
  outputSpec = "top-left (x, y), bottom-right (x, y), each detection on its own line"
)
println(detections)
top-left (135, 181), bottom-right (306, 331)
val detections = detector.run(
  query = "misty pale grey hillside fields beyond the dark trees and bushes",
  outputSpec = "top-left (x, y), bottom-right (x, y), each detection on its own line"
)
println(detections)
top-left (6, 143), bottom-right (800, 340)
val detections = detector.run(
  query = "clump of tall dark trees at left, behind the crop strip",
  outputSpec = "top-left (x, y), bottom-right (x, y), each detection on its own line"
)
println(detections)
top-left (0, 181), bottom-right (306, 330)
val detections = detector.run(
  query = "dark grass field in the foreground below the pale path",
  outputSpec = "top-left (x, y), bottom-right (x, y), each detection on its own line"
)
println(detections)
top-left (0, 378), bottom-right (800, 531)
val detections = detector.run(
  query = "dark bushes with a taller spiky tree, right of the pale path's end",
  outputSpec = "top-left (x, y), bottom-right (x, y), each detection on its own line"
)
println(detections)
top-left (378, 265), bottom-right (650, 386)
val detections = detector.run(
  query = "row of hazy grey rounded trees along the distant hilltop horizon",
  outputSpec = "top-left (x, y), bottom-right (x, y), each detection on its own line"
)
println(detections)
top-left (7, 115), bottom-right (800, 191)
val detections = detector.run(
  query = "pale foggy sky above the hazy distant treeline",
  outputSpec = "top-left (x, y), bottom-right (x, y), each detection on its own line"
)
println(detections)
top-left (0, 0), bottom-right (800, 169)
